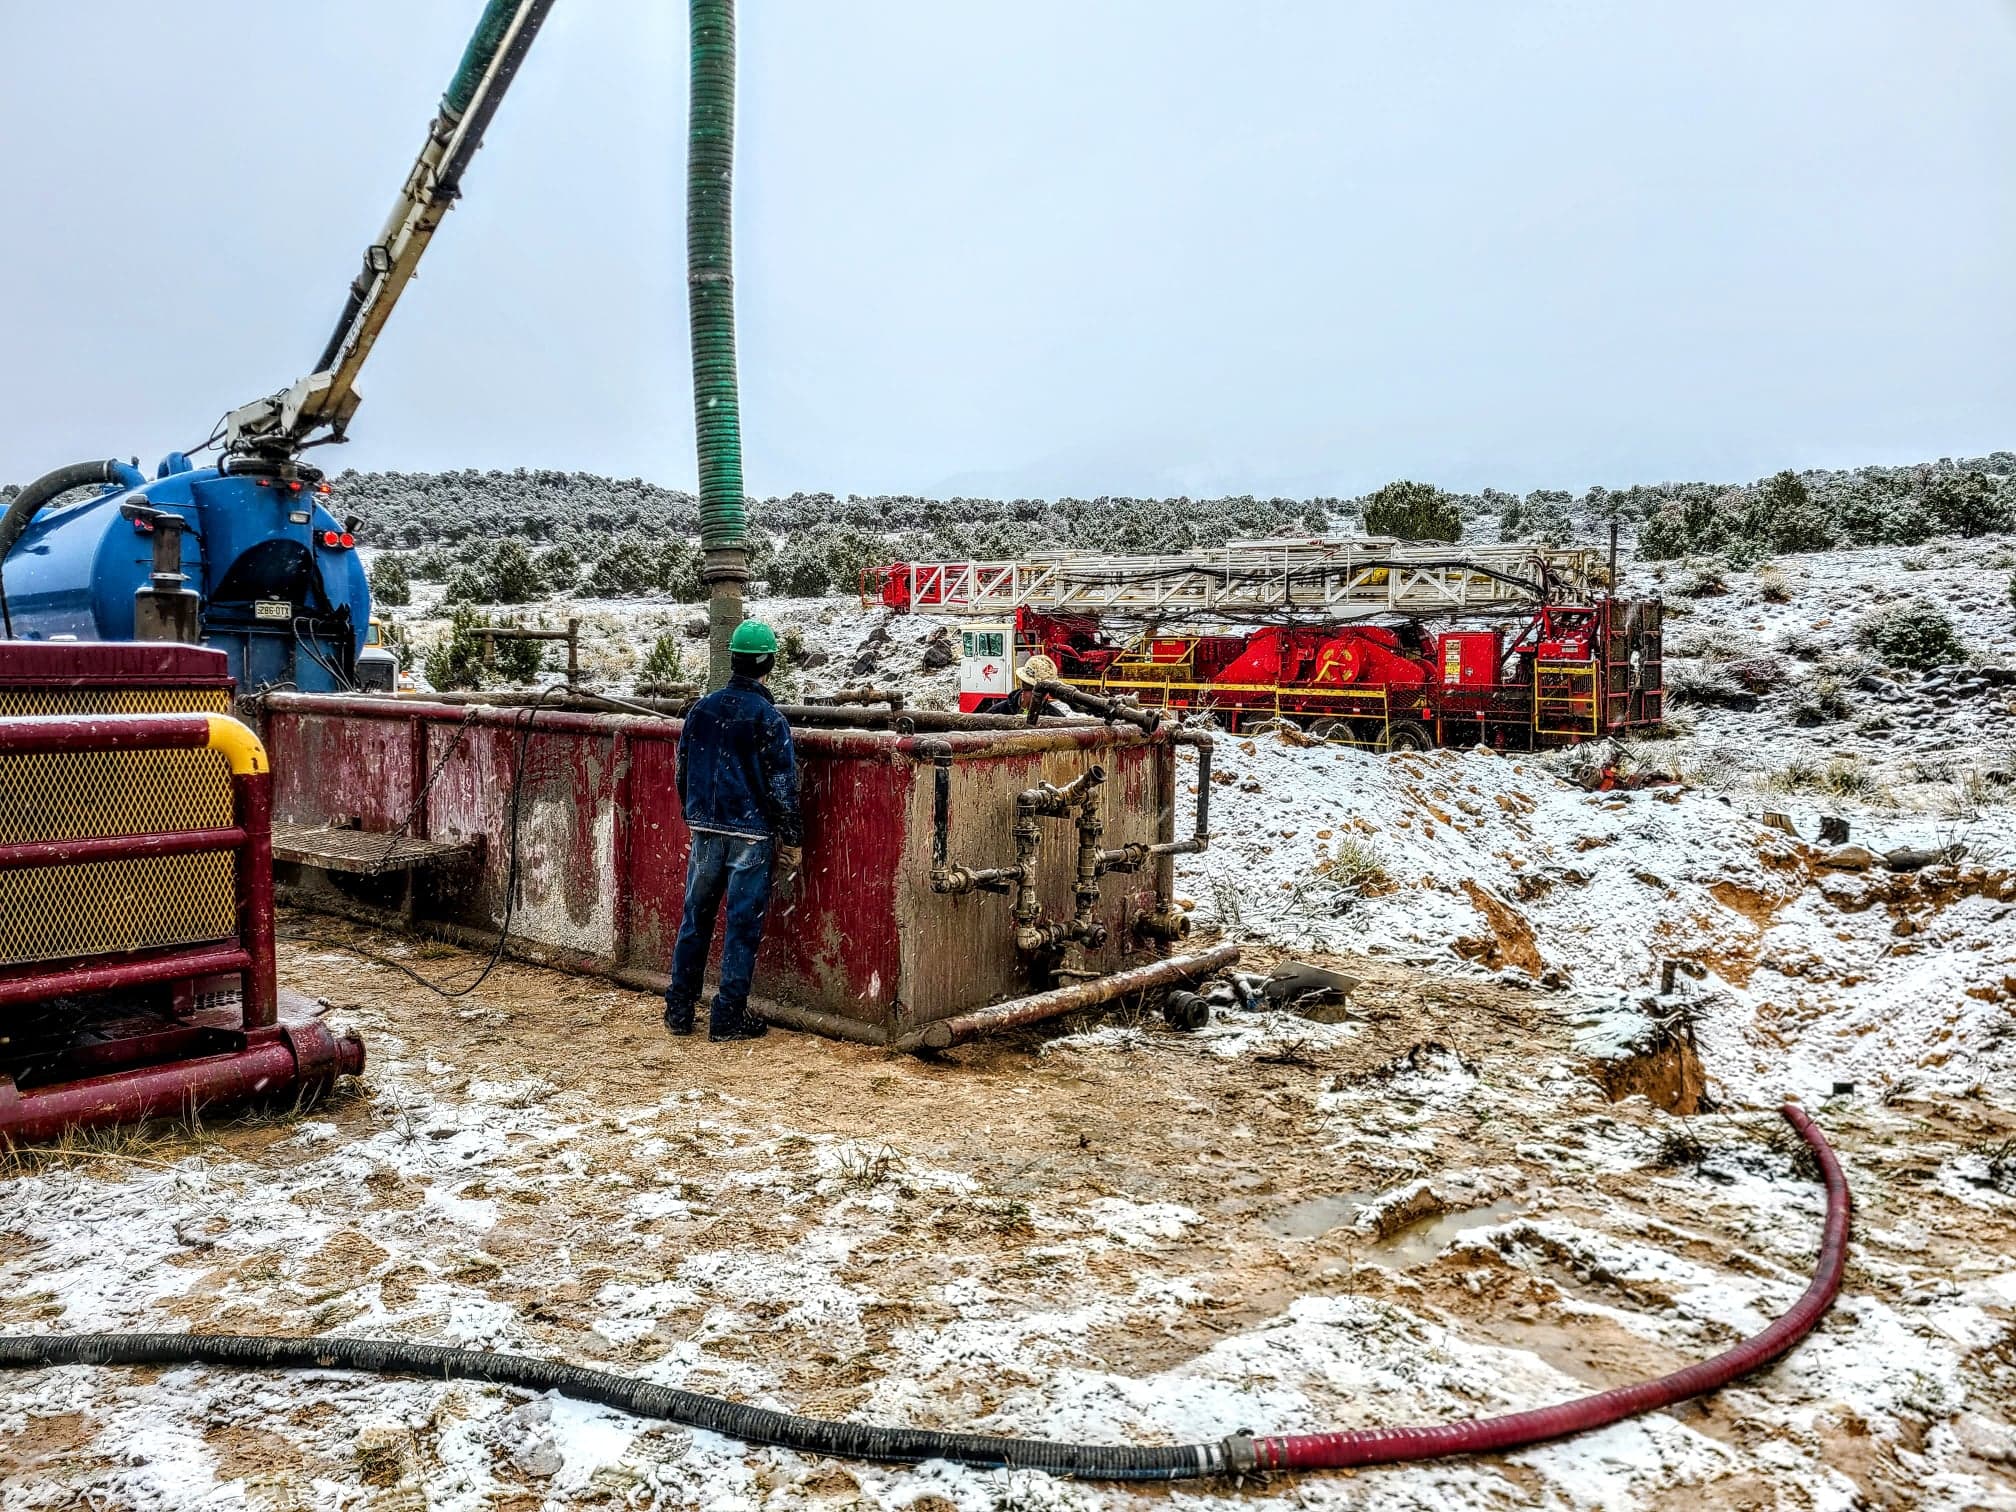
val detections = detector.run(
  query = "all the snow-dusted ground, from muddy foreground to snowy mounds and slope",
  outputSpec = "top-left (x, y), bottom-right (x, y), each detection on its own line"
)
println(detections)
top-left (0, 542), bottom-right (2016, 1512)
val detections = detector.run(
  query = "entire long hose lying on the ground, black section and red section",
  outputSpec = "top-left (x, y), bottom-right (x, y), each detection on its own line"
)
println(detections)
top-left (0, 1105), bottom-right (1851, 1480)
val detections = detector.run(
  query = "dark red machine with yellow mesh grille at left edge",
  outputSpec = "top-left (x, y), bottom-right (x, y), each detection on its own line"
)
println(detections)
top-left (0, 641), bottom-right (363, 1143)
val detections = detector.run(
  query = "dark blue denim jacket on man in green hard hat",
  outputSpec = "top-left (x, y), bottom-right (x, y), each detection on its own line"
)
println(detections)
top-left (679, 677), bottom-right (804, 845)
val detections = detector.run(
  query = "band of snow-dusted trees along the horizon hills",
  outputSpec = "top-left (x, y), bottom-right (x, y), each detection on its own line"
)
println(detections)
top-left (333, 452), bottom-right (2016, 603)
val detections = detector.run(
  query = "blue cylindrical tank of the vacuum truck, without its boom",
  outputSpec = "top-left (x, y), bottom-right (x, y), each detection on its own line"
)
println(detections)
top-left (0, 452), bottom-right (371, 694)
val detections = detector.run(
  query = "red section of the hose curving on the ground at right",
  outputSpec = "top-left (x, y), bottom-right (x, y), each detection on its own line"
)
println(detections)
top-left (1252, 1103), bottom-right (1851, 1470)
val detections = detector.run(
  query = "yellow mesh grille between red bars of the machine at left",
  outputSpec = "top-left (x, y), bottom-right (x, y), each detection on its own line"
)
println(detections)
top-left (0, 687), bottom-right (236, 966)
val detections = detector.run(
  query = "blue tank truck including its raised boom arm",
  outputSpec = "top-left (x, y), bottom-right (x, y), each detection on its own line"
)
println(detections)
top-left (0, 0), bottom-right (552, 694)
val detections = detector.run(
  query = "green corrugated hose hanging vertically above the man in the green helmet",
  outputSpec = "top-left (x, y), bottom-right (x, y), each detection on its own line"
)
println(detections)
top-left (685, 0), bottom-right (748, 687)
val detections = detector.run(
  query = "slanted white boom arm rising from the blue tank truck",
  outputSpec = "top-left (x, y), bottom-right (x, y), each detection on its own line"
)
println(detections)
top-left (224, 0), bottom-right (552, 456)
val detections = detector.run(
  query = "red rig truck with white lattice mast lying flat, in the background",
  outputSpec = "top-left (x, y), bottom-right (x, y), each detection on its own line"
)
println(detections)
top-left (863, 536), bottom-right (1663, 750)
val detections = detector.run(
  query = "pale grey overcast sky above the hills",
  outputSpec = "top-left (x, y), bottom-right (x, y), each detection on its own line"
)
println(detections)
top-left (0, 0), bottom-right (2016, 494)
